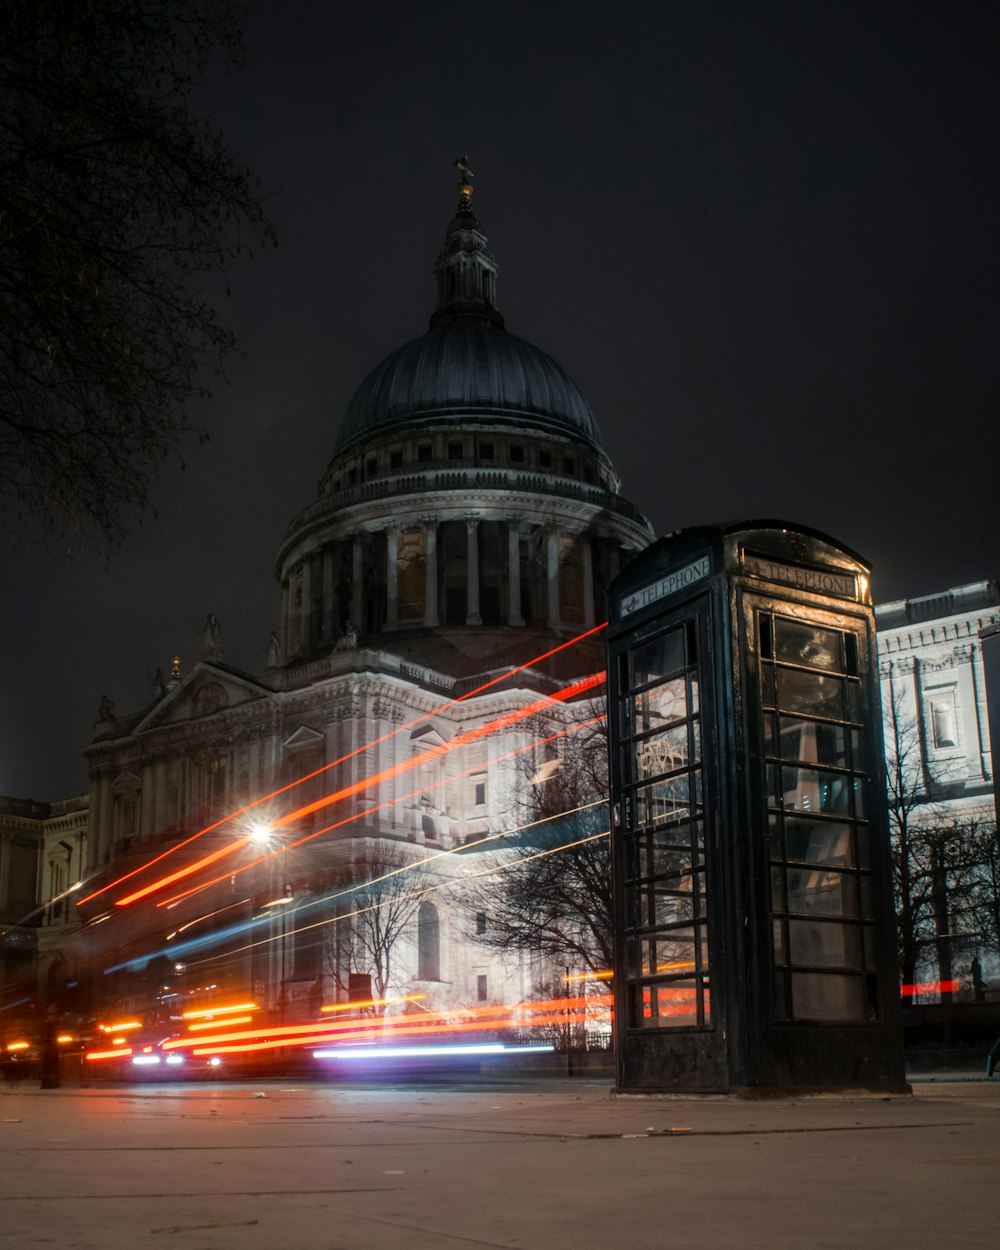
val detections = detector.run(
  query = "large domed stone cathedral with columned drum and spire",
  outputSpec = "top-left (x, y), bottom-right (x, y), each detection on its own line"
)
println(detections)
top-left (68, 179), bottom-right (651, 1019)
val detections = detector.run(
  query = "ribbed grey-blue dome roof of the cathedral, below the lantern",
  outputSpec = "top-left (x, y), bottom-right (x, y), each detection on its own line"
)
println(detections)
top-left (338, 319), bottom-right (601, 451)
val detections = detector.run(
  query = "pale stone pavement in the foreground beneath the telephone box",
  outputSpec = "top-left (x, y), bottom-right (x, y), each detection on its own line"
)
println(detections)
top-left (0, 1079), bottom-right (1000, 1250)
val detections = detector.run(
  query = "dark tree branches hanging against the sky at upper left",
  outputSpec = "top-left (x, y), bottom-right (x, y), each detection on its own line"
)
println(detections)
top-left (0, 0), bottom-right (273, 553)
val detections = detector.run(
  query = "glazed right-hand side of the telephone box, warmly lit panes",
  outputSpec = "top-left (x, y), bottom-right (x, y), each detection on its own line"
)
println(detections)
top-left (758, 611), bottom-right (875, 1024)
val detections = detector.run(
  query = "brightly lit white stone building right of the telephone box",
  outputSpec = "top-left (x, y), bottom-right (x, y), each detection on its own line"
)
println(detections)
top-left (875, 581), bottom-right (1000, 1004)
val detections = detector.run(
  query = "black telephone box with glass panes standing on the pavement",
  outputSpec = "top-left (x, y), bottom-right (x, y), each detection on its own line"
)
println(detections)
top-left (608, 521), bottom-right (903, 1091)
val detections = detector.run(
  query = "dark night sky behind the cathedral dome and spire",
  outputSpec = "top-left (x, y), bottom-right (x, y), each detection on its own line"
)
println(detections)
top-left (0, 0), bottom-right (1000, 799)
